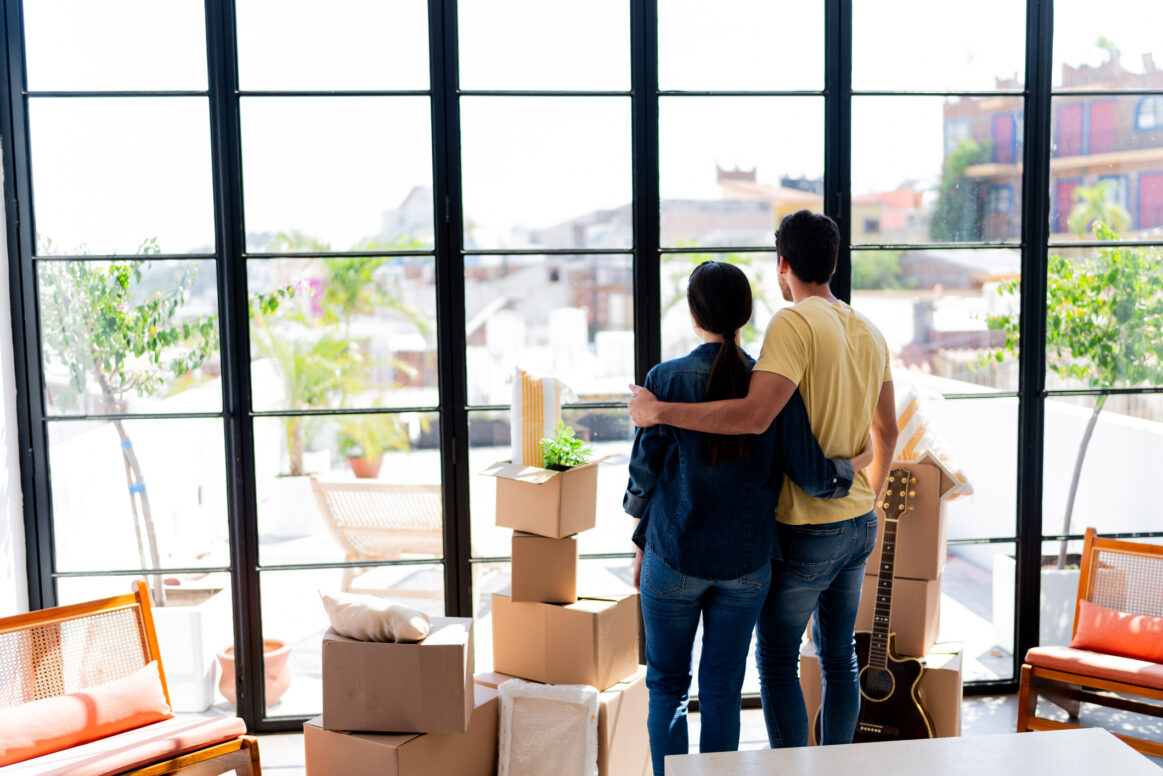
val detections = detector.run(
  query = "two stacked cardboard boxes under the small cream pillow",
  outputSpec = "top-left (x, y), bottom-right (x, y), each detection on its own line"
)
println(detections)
top-left (304, 617), bottom-right (498, 776)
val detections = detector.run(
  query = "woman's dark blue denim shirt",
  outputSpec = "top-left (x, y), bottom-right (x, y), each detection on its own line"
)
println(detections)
top-left (622, 342), bottom-right (854, 579)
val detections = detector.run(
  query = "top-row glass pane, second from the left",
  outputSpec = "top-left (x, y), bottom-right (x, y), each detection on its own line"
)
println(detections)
top-left (235, 0), bottom-right (428, 90)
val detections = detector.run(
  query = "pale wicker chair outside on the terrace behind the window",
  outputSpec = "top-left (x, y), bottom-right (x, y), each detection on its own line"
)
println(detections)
top-left (311, 477), bottom-right (444, 598)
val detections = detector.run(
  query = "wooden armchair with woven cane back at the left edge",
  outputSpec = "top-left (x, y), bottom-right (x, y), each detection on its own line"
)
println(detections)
top-left (0, 582), bottom-right (262, 776)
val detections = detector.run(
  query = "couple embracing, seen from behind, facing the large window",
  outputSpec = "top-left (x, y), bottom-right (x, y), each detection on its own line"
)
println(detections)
top-left (623, 211), bottom-right (897, 775)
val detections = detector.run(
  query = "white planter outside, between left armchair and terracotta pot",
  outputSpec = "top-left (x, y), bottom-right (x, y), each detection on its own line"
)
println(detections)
top-left (152, 589), bottom-right (234, 712)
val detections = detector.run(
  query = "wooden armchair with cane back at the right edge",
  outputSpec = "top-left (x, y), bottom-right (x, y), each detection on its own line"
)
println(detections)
top-left (1018, 528), bottom-right (1163, 756)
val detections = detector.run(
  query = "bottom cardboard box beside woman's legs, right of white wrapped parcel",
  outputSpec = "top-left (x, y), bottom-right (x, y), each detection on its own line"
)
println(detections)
top-left (598, 665), bottom-right (651, 776)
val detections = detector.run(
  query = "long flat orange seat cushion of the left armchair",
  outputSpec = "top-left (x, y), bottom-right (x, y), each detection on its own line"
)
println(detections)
top-left (0, 717), bottom-right (247, 776)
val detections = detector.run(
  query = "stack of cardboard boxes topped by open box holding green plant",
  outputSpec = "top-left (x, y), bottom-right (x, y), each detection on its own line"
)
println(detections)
top-left (477, 462), bottom-right (650, 776)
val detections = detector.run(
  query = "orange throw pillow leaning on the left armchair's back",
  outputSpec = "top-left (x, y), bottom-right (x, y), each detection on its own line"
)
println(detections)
top-left (0, 661), bottom-right (173, 766)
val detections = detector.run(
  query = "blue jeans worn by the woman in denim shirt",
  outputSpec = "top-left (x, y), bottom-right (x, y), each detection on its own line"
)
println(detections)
top-left (641, 547), bottom-right (771, 776)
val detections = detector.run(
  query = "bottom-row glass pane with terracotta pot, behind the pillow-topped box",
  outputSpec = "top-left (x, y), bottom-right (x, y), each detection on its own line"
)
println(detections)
top-left (259, 563), bottom-right (444, 717)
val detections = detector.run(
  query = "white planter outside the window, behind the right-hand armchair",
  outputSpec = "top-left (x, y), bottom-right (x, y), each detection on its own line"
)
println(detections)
top-left (993, 553), bottom-right (1078, 654)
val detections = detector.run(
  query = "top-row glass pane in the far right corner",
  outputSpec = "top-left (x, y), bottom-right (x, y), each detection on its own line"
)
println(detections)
top-left (1054, 0), bottom-right (1163, 90)
